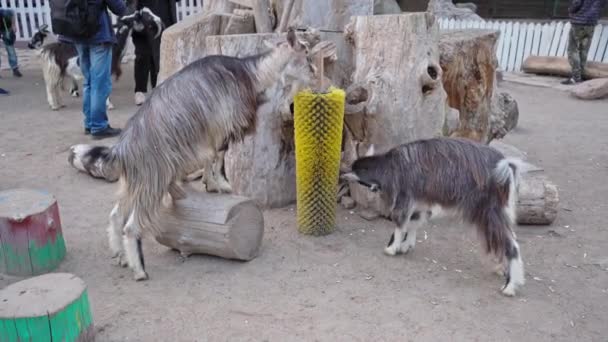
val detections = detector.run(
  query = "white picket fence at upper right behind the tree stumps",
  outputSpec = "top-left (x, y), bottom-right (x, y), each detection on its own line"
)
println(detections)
top-left (439, 19), bottom-right (608, 71)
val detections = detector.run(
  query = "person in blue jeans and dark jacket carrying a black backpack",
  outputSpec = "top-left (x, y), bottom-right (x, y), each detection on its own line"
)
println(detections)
top-left (58, 0), bottom-right (127, 139)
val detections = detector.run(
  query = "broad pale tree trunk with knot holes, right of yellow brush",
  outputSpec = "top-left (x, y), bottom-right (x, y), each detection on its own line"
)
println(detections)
top-left (344, 13), bottom-right (447, 211)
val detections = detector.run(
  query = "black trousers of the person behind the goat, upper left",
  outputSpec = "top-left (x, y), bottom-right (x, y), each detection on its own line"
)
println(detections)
top-left (132, 32), bottom-right (160, 93)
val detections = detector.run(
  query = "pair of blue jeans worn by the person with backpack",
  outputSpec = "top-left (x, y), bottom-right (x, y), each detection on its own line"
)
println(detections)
top-left (74, 44), bottom-right (112, 133)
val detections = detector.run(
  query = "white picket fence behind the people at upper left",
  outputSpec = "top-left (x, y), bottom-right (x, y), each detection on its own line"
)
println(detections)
top-left (0, 0), bottom-right (203, 41)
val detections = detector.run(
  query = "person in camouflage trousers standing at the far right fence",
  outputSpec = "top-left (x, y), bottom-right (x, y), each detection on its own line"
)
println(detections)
top-left (562, 0), bottom-right (606, 84)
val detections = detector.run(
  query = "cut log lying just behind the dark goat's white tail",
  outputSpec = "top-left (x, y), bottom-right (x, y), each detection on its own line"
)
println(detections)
top-left (517, 171), bottom-right (559, 225)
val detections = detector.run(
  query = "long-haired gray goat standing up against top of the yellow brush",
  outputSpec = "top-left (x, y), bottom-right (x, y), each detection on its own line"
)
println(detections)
top-left (69, 29), bottom-right (315, 280)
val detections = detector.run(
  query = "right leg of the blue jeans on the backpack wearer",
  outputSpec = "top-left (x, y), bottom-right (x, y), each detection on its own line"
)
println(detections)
top-left (90, 44), bottom-right (112, 136)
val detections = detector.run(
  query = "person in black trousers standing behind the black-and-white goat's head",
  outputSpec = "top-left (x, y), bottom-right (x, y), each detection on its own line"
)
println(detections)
top-left (131, 0), bottom-right (179, 106)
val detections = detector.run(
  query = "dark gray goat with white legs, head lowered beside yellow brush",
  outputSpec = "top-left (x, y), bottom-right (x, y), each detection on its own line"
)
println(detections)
top-left (342, 138), bottom-right (526, 296)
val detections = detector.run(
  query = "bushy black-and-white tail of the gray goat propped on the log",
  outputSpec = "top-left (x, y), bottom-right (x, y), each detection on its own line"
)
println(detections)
top-left (68, 144), bottom-right (120, 182)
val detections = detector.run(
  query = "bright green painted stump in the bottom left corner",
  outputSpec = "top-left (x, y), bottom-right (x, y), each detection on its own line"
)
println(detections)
top-left (0, 273), bottom-right (95, 342)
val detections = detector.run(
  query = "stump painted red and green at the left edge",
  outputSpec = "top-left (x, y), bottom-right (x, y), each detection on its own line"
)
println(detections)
top-left (0, 189), bottom-right (66, 276)
